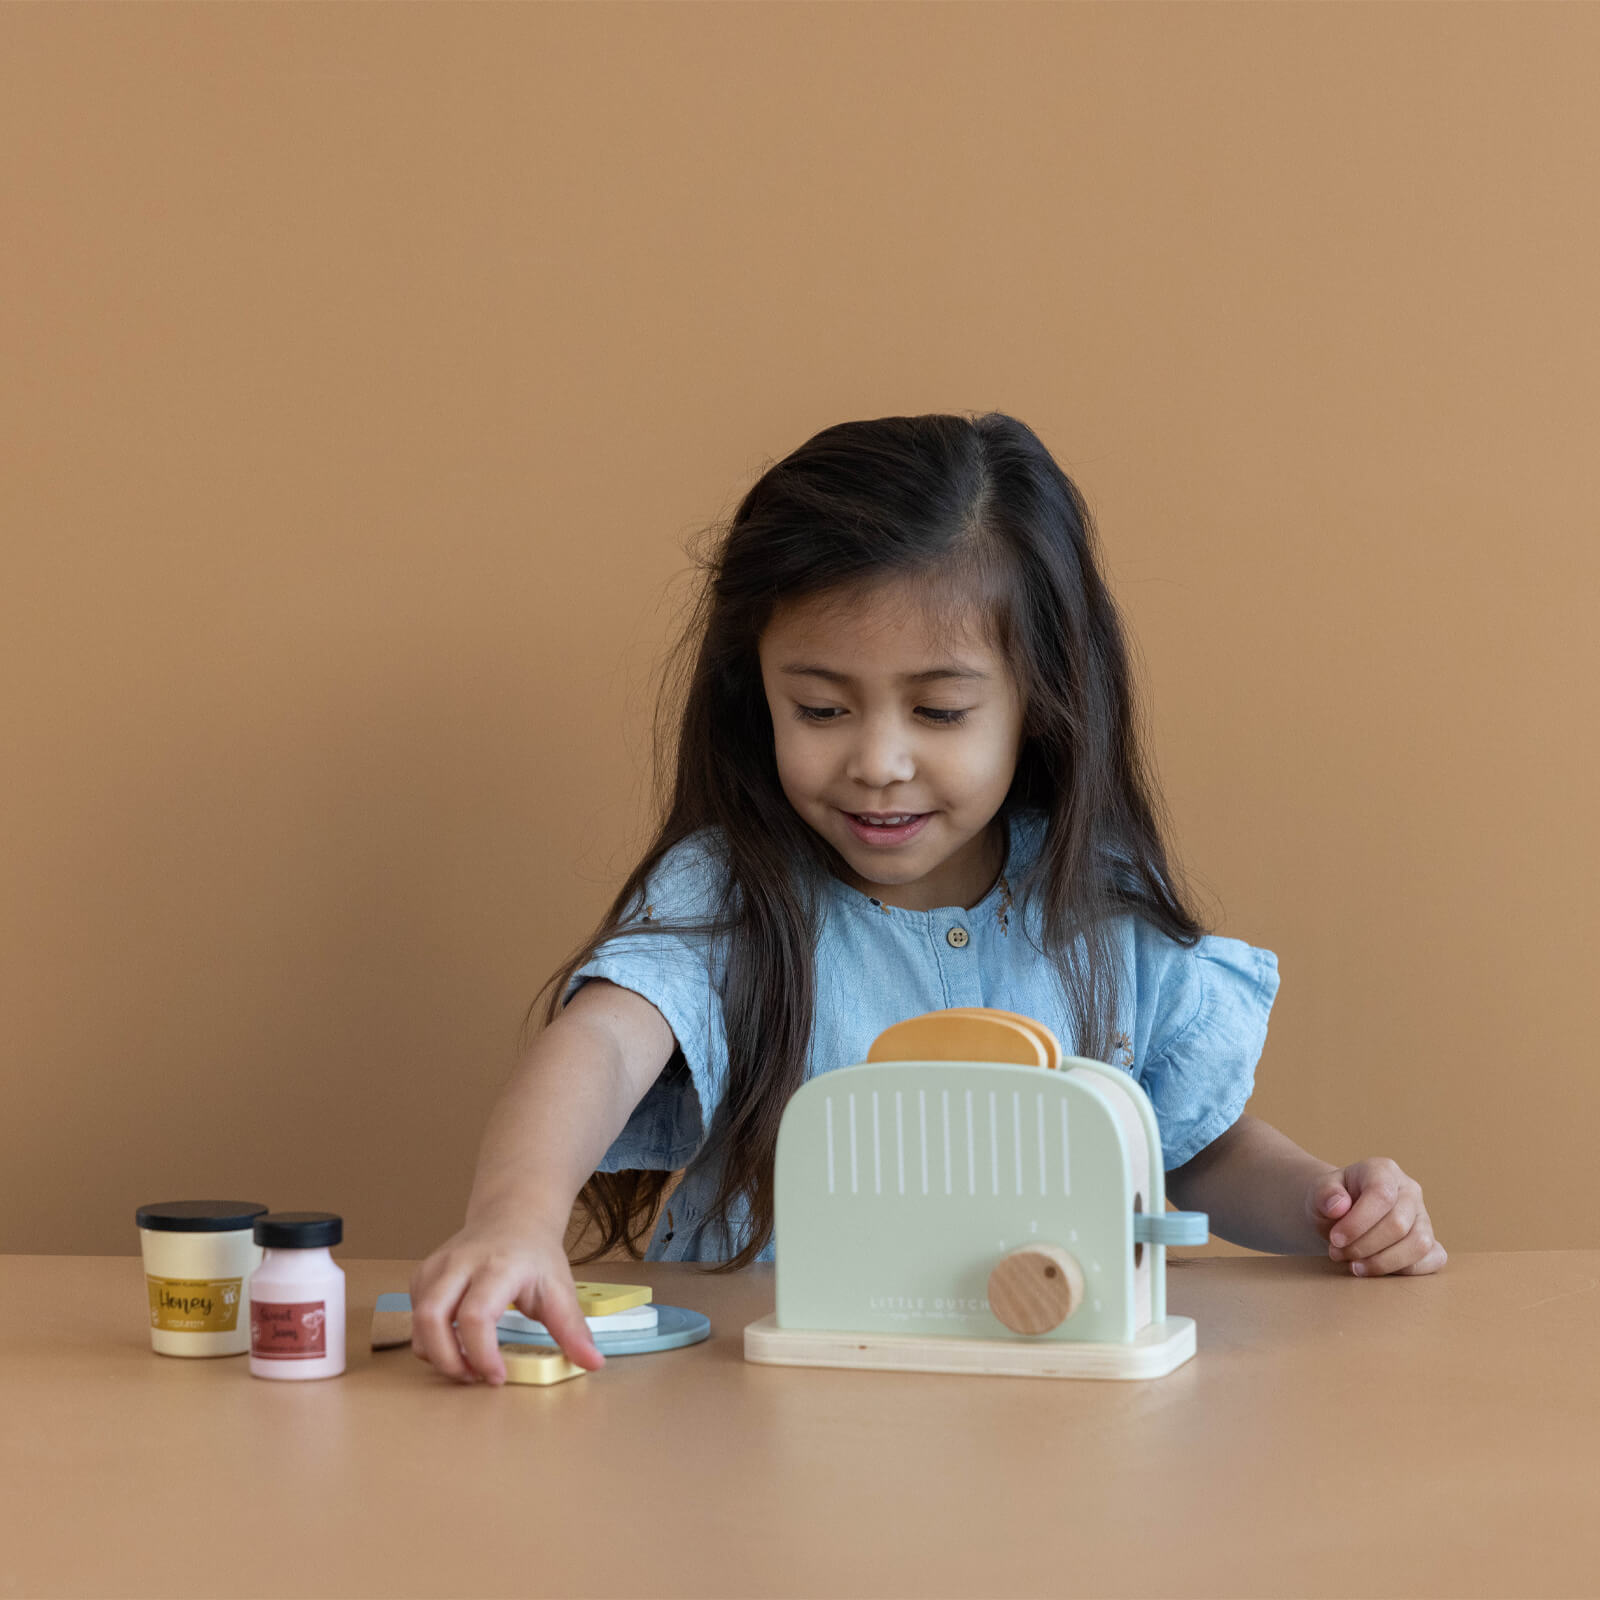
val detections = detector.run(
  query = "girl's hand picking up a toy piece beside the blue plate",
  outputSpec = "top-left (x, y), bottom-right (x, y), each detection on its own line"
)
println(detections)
top-left (411, 1222), bottom-right (605, 1386)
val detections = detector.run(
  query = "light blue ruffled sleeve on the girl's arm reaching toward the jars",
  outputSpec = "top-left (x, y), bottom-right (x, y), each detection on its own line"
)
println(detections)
top-left (562, 832), bottom-right (728, 1173)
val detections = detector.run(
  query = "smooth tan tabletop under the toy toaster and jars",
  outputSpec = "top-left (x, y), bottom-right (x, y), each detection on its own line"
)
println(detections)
top-left (0, 1251), bottom-right (1600, 1597)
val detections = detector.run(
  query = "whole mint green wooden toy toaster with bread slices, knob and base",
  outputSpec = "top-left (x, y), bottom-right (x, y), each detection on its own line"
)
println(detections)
top-left (744, 1006), bottom-right (1206, 1378)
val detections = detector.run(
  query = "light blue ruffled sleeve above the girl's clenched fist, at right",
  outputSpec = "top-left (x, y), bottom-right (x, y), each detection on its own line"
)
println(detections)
top-left (1134, 918), bottom-right (1278, 1171)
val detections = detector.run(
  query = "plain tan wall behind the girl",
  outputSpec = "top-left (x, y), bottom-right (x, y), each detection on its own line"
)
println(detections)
top-left (0, 3), bottom-right (1600, 1256)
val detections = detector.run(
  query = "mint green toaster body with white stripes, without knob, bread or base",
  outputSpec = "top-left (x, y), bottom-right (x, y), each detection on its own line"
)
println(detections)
top-left (773, 1056), bottom-right (1205, 1344)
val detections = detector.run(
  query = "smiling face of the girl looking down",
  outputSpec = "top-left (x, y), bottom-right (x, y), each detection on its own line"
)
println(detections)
top-left (758, 581), bottom-right (1022, 910)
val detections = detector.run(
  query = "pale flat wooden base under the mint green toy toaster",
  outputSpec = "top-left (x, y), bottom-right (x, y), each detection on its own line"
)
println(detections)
top-left (744, 1314), bottom-right (1195, 1378)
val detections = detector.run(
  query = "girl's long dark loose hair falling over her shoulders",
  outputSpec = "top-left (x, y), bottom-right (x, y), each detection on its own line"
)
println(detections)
top-left (525, 411), bottom-right (1208, 1272)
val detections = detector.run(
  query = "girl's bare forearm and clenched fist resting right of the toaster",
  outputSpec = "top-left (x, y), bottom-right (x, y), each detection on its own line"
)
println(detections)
top-left (1166, 1115), bottom-right (1448, 1277)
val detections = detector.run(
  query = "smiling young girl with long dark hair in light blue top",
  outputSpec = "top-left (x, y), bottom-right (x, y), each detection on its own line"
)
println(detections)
top-left (411, 413), bottom-right (1445, 1384)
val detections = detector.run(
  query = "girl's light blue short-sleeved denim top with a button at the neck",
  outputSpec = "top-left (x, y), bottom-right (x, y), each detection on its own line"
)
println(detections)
top-left (562, 811), bottom-right (1278, 1261)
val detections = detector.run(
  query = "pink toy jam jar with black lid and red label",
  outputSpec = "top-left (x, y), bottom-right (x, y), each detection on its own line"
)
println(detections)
top-left (250, 1211), bottom-right (344, 1378)
